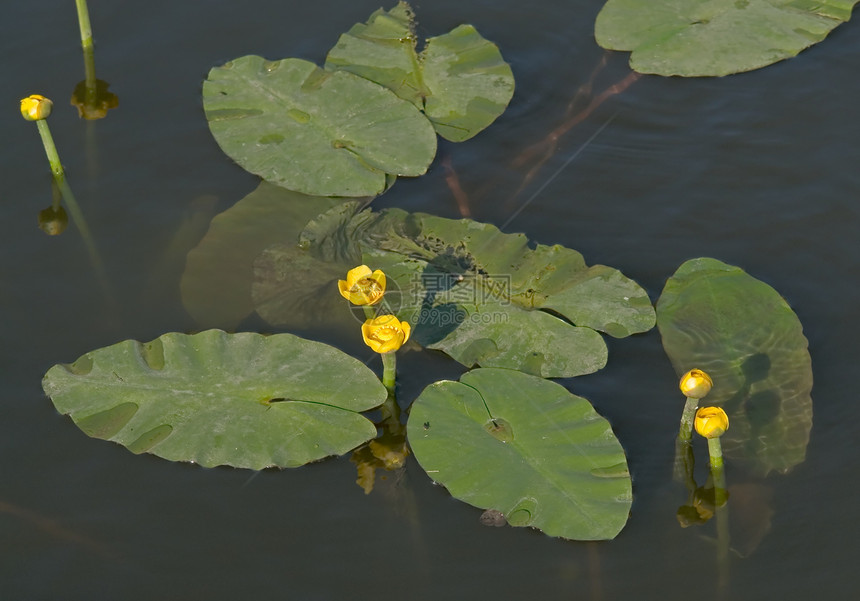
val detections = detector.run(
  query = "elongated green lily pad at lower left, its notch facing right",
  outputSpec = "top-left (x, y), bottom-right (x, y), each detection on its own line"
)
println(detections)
top-left (42, 330), bottom-right (387, 470)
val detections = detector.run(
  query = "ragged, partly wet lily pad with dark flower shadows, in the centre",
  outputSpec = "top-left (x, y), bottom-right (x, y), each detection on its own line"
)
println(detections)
top-left (266, 205), bottom-right (655, 377)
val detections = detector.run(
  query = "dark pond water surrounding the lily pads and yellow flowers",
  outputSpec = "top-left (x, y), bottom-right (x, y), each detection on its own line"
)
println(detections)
top-left (0, 0), bottom-right (860, 601)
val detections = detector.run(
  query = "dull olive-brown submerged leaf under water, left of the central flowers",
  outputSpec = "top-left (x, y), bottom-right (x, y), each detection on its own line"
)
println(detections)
top-left (181, 182), bottom-right (358, 329)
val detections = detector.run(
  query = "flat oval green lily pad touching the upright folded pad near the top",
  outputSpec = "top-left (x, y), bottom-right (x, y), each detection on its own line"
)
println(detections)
top-left (203, 56), bottom-right (436, 197)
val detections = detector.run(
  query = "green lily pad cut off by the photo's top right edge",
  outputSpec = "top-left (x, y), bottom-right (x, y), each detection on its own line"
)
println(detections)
top-left (594, 0), bottom-right (857, 77)
